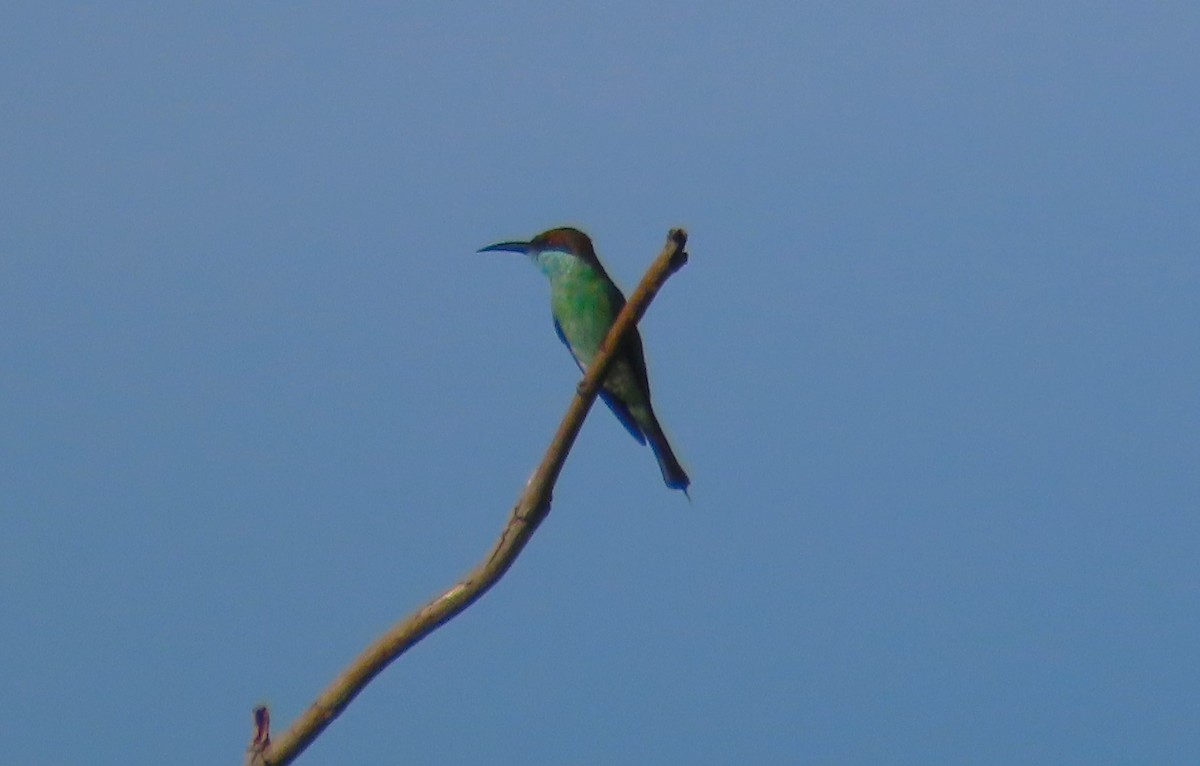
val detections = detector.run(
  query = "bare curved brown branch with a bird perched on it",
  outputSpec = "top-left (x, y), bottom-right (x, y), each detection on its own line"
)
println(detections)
top-left (246, 229), bottom-right (688, 766)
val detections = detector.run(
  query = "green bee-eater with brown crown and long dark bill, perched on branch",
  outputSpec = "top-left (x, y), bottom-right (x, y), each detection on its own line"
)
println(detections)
top-left (479, 227), bottom-right (691, 495)
